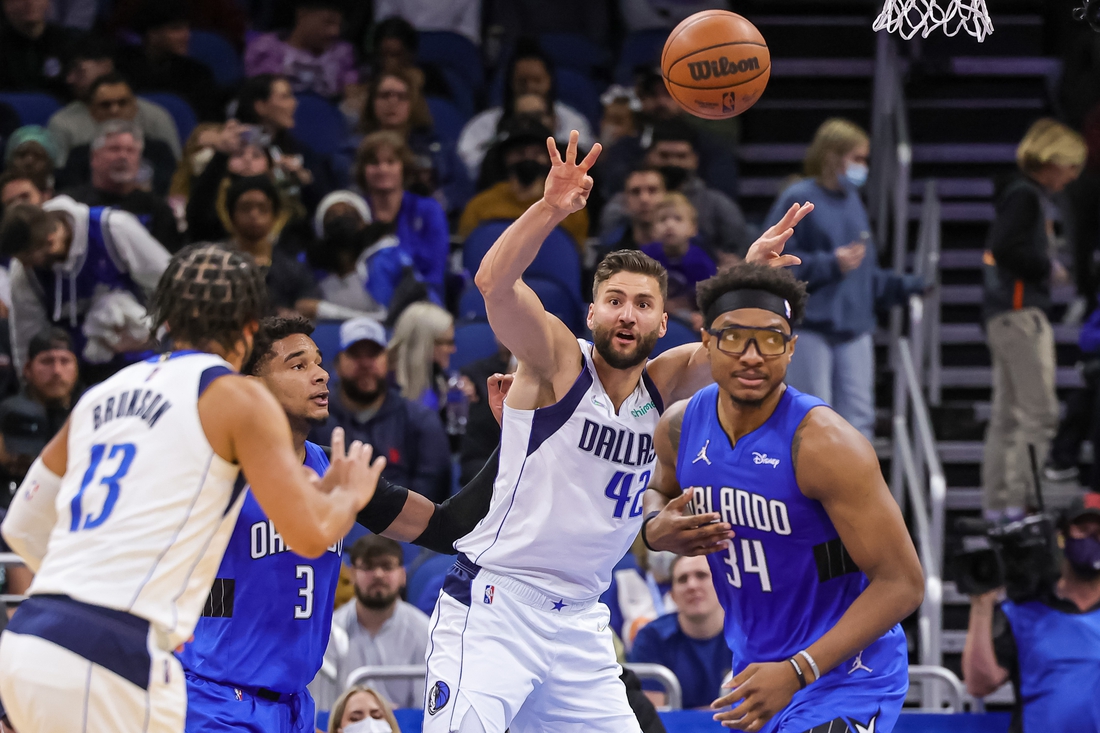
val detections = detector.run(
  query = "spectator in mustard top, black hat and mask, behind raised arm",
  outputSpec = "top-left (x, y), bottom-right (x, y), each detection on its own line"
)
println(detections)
top-left (459, 119), bottom-right (589, 245)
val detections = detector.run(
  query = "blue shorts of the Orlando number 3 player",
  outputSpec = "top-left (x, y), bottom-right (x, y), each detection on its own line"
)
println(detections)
top-left (185, 672), bottom-right (317, 733)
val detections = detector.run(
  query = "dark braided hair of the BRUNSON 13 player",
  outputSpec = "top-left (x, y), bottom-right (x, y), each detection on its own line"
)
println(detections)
top-left (150, 243), bottom-right (267, 349)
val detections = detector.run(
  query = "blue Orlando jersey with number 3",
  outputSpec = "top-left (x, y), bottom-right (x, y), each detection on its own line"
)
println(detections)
top-left (178, 442), bottom-right (343, 693)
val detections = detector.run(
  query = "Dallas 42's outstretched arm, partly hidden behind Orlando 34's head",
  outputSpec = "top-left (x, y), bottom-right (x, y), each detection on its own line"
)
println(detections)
top-left (647, 201), bottom-right (814, 404)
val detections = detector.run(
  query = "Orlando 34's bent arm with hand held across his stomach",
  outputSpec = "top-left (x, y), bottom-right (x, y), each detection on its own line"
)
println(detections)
top-left (641, 401), bottom-right (734, 555)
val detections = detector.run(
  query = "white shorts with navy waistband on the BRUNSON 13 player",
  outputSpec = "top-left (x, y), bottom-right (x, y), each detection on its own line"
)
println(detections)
top-left (0, 597), bottom-right (187, 733)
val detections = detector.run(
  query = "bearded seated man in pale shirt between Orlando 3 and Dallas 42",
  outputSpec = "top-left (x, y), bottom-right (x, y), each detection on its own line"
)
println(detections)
top-left (326, 535), bottom-right (428, 708)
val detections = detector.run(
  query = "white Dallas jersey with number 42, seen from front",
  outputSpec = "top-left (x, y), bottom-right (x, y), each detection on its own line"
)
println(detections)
top-left (455, 340), bottom-right (663, 600)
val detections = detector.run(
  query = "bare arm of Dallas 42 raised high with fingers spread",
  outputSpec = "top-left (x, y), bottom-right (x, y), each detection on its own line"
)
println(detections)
top-left (474, 130), bottom-right (601, 376)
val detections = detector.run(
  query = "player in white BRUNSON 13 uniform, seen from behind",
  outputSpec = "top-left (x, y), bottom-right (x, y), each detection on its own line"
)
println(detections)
top-left (0, 244), bottom-right (385, 733)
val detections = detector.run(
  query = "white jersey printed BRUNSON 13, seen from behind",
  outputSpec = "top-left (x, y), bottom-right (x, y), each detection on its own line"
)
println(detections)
top-left (29, 351), bottom-right (244, 649)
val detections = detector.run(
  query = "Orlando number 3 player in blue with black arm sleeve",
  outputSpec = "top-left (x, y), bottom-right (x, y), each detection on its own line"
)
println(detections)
top-left (177, 318), bottom-right (509, 733)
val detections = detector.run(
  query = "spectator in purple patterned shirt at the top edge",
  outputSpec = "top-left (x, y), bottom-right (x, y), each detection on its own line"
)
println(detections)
top-left (244, 0), bottom-right (359, 99)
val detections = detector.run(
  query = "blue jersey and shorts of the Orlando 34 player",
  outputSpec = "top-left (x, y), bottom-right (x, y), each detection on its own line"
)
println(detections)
top-left (677, 384), bottom-right (909, 731)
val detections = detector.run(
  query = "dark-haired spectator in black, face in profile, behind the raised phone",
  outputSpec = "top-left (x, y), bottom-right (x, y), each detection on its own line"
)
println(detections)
top-left (237, 74), bottom-right (336, 202)
